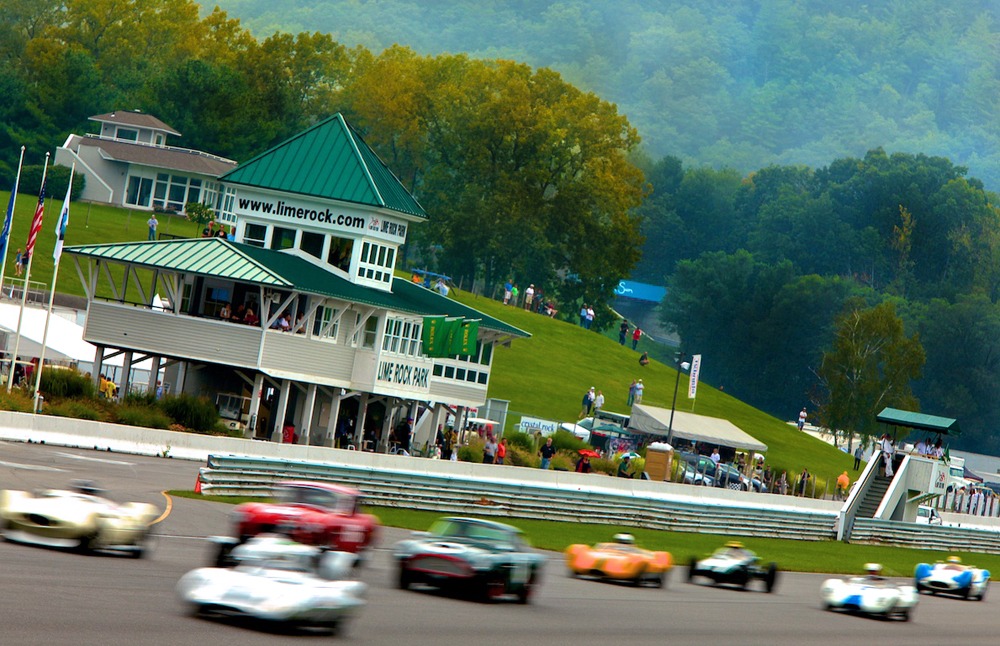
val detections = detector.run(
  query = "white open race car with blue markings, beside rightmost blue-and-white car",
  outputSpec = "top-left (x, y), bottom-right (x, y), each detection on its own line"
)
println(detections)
top-left (820, 563), bottom-right (919, 621)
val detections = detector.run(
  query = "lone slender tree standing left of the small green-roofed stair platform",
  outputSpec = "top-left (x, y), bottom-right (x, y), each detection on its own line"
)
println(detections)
top-left (817, 301), bottom-right (925, 446)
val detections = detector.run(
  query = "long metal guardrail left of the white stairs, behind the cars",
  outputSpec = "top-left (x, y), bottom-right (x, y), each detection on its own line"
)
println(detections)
top-left (199, 455), bottom-right (836, 541)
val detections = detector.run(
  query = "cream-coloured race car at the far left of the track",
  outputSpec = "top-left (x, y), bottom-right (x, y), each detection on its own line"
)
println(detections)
top-left (0, 482), bottom-right (159, 558)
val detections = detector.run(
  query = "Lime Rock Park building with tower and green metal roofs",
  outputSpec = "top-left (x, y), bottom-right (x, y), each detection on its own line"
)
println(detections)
top-left (66, 114), bottom-right (528, 450)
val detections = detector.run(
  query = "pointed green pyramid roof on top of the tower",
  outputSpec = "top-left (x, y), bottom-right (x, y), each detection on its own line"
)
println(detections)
top-left (221, 113), bottom-right (427, 219)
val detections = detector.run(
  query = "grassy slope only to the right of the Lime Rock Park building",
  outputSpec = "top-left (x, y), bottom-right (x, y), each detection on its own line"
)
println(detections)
top-left (452, 292), bottom-right (854, 489)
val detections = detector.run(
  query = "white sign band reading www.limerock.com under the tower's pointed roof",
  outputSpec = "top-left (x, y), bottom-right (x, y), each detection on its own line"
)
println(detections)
top-left (233, 188), bottom-right (409, 243)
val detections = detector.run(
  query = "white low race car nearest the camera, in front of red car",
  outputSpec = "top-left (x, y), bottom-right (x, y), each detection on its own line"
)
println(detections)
top-left (177, 534), bottom-right (368, 633)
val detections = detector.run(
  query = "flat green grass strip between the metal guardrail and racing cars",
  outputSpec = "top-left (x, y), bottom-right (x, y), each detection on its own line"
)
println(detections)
top-left (168, 490), bottom-right (1000, 577)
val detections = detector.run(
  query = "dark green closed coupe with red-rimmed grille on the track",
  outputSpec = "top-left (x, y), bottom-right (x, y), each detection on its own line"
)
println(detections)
top-left (393, 517), bottom-right (545, 603)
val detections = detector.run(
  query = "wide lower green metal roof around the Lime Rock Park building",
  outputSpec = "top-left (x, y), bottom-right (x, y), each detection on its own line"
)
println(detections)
top-left (66, 238), bottom-right (531, 338)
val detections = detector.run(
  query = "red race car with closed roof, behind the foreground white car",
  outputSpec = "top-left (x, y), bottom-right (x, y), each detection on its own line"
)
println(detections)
top-left (232, 482), bottom-right (378, 553)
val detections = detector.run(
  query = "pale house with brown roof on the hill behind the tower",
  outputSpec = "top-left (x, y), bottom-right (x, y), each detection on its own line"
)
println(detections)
top-left (55, 110), bottom-right (236, 221)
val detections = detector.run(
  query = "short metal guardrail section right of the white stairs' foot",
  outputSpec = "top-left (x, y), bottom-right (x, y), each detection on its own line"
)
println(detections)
top-left (851, 518), bottom-right (1000, 553)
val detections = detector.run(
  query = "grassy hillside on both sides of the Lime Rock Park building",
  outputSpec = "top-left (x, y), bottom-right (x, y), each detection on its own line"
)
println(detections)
top-left (0, 192), bottom-right (852, 489)
